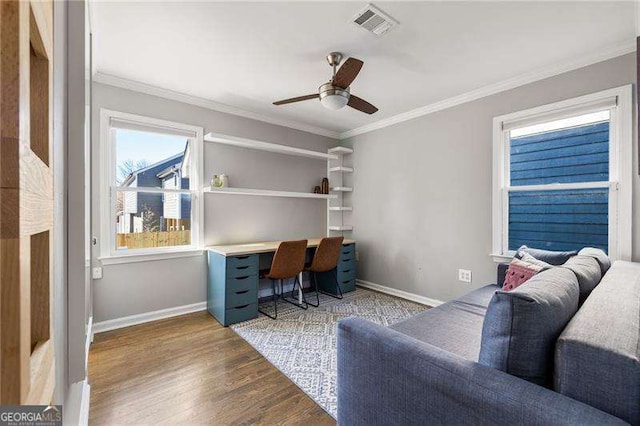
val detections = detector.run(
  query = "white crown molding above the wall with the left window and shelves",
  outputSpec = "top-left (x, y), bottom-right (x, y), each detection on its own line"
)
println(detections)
top-left (93, 72), bottom-right (340, 139)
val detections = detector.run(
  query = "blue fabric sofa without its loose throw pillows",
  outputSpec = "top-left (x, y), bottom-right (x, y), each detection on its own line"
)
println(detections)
top-left (337, 255), bottom-right (640, 425)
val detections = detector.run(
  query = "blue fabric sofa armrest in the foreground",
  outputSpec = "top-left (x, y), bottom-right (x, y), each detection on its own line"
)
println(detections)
top-left (338, 318), bottom-right (626, 426)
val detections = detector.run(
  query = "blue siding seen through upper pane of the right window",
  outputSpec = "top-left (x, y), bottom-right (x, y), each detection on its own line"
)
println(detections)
top-left (510, 121), bottom-right (609, 186)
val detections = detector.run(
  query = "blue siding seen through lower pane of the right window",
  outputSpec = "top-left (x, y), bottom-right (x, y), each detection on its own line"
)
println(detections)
top-left (509, 189), bottom-right (609, 252)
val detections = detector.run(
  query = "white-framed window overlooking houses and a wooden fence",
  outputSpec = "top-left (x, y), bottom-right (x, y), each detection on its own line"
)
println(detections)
top-left (101, 110), bottom-right (203, 258)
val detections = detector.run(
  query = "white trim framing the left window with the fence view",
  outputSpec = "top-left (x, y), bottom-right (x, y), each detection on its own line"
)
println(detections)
top-left (99, 108), bottom-right (204, 265)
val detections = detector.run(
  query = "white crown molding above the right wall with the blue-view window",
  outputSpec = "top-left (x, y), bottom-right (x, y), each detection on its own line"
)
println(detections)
top-left (339, 40), bottom-right (636, 140)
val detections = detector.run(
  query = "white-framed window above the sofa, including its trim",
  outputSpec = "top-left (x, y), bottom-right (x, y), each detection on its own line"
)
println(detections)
top-left (493, 86), bottom-right (632, 260)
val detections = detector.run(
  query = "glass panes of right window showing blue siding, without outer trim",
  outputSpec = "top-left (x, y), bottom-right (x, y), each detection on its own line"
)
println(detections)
top-left (508, 111), bottom-right (609, 252)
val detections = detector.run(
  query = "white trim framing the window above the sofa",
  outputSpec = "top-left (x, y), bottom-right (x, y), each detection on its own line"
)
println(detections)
top-left (491, 84), bottom-right (633, 262)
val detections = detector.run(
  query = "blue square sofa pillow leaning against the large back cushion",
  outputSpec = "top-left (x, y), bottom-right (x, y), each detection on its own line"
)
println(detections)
top-left (478, 268), bottom-right (580, 386)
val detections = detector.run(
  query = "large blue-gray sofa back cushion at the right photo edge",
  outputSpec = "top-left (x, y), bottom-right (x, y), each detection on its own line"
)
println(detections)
top-left (554, 261), bottom-right (640, 425)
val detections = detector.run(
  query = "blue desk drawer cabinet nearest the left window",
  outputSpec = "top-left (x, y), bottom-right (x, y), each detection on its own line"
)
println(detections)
top-left (207, 251), bottom-right (259, 326)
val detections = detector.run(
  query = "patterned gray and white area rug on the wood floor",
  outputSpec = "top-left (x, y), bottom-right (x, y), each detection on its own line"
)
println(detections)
top-left (231, 288), bottom-right (427, 418)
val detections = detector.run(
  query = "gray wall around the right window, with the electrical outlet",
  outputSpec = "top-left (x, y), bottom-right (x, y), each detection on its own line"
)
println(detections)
top-left (344, 54), bottom-right (640, 300)
